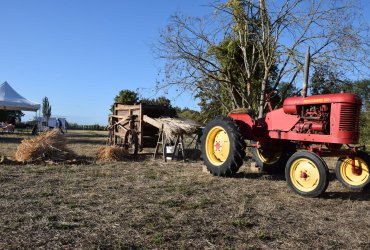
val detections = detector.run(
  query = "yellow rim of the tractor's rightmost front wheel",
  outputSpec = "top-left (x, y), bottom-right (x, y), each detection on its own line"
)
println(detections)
top-left (340, 157), bottom-right (369, 186)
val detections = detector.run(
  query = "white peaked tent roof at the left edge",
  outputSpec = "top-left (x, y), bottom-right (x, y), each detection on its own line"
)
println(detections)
top-left (0, 82), bottom-right (40, 111)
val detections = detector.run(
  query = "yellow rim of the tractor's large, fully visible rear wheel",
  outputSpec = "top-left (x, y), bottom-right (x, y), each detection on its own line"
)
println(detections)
top-left (205, 126), bottom-right (230, 166)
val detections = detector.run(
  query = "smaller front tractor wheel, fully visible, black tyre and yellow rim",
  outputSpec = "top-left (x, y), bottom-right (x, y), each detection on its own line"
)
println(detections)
top-left (285, 151), bottom-right (329, 197)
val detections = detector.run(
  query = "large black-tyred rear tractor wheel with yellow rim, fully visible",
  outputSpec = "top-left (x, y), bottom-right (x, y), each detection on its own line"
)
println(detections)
top-left (201, 116), bottom-right (246, 176)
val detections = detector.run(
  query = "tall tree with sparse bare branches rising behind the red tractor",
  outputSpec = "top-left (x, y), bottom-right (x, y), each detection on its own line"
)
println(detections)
top-left (154, 0), bottom-right (370, 117)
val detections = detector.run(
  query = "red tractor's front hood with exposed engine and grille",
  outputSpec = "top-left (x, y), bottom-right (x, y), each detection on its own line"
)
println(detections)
top-left (282, 93), bottom-right (361, 144)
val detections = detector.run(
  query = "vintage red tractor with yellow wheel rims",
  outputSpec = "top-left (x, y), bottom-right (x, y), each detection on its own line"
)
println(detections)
top-left (202, 54), bottom-right (370, 197)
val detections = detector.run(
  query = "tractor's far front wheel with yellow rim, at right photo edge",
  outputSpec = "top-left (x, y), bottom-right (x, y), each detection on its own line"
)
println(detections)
top-left (335, 151), bottom-right (370, 190)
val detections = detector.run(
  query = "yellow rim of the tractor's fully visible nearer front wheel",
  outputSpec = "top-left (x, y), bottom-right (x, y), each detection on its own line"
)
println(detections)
top-left (290, 158), bottom-right (320, 192)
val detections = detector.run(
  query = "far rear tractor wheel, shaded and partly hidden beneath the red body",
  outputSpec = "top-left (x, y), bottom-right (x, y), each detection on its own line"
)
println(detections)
top-left (252, 142), bottom-right (296, 174)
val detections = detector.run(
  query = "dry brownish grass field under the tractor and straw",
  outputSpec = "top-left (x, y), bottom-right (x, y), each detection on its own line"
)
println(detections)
top-left (0, 131), bottom-right (370, 249)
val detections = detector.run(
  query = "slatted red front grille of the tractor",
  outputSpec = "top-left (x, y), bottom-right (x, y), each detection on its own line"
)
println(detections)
top-left (339, 105), bottom-right (360, 132)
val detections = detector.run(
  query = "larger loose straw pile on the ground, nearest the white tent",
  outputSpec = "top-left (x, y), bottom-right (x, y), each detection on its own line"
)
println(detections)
top-left (15, 129), bottom-right (76, 162)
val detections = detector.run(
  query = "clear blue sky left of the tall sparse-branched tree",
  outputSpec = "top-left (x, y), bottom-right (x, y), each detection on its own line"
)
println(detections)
top-left (0, 0), bottom-right (209, 125)
